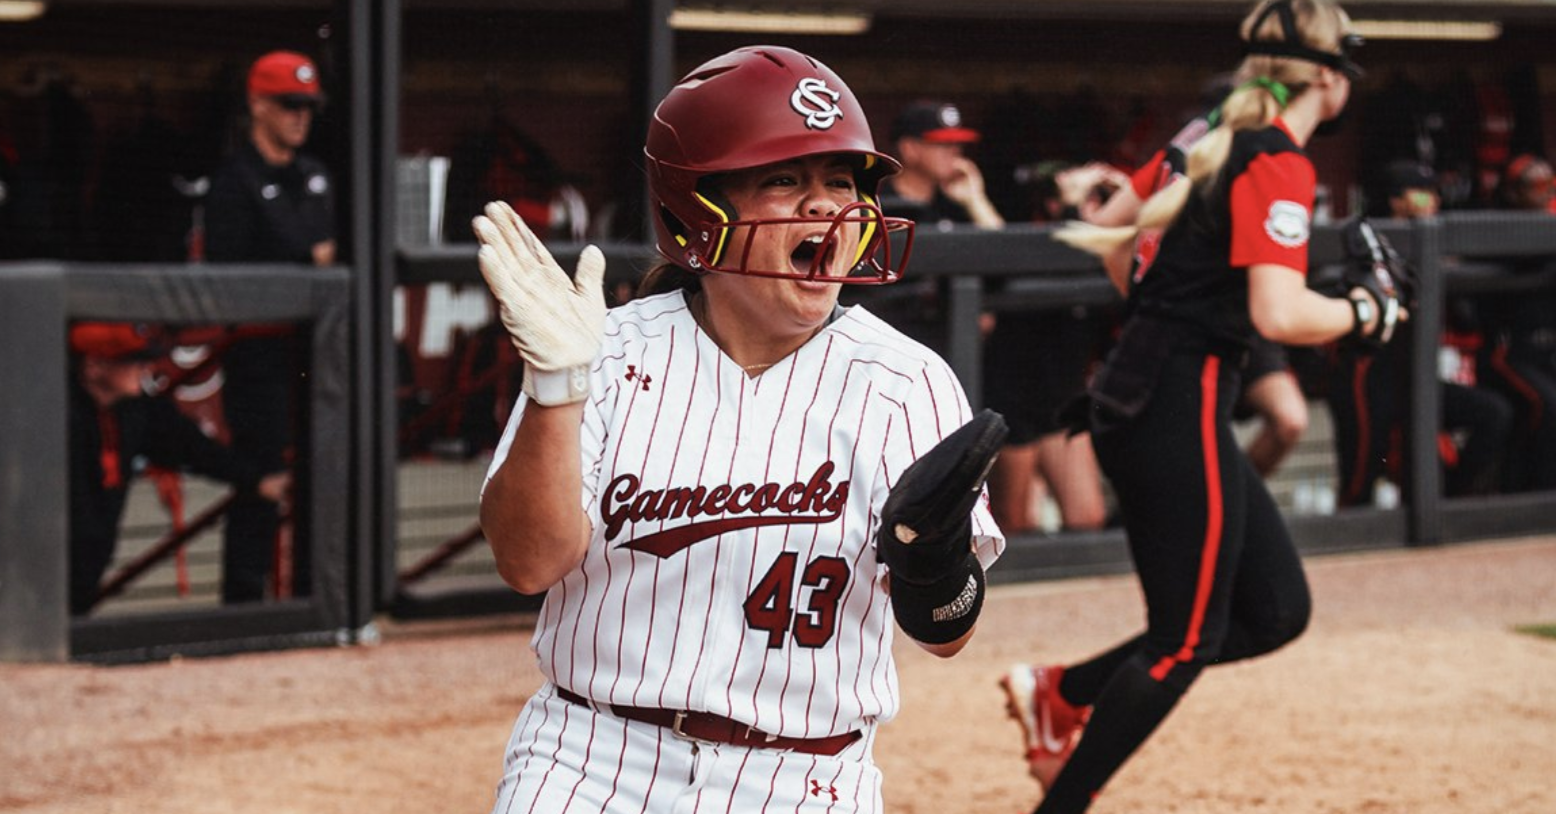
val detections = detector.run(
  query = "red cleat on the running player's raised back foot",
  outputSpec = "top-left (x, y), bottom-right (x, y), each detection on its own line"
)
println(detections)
top-left (999, 665), bottom-right (1091, 789)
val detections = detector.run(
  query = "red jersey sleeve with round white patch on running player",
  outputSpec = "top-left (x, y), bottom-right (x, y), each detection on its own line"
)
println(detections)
top-left (1231, 153), bottom-right (1318, 274)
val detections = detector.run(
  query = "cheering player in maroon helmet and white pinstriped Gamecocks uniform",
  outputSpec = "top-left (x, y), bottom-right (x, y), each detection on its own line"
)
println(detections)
top-left (476, 47), bottom-right (1004, 812)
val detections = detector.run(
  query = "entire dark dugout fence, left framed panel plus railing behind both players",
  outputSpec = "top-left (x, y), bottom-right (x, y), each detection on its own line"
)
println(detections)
top-left (0, 212), bottom-right (1556, 660)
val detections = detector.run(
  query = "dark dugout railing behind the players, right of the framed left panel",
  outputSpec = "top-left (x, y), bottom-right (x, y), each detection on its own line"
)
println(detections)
top-left (385, 212), bottom-right (1556, 613)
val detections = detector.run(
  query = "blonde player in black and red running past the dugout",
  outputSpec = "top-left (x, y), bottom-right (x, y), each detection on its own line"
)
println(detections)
top-left (1004, 0), bottom-right (1399, 814)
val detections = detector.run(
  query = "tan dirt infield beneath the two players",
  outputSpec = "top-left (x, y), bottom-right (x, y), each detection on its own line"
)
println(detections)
top-left (0, 537), bottom-right (1556, 814)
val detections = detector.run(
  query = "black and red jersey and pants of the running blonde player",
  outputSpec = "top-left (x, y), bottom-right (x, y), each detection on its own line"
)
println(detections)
top-left (1038, 121), bottom-right (1315, 812)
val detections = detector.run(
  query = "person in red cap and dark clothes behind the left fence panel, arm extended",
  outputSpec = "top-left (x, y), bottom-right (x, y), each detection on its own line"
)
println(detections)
top-left (70, 322), bottom-right (291, 616)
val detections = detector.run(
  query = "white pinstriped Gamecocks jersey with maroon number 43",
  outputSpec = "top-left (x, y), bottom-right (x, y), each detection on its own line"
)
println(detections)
top-left (492, 293), bottom-right (1005, 738)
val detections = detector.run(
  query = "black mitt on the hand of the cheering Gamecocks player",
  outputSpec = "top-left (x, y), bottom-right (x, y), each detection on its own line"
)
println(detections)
top-left (876, 409), bottom-right (1008, 585)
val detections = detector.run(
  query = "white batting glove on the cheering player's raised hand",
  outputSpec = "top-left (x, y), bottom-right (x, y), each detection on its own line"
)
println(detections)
top-left (473, 201), bottom-right (605, 406)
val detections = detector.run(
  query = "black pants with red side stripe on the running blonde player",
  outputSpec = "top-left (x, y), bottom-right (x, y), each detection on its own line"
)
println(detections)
top-left (1038, 352), bottom-right (1312, 814)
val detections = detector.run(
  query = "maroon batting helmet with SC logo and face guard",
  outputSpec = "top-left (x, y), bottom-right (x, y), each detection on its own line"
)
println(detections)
top-left (643, 45), bottom-right (913, 283)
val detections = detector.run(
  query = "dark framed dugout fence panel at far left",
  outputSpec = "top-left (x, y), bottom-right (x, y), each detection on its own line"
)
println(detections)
top-left (0, 263), bottom-right (357, 660)
